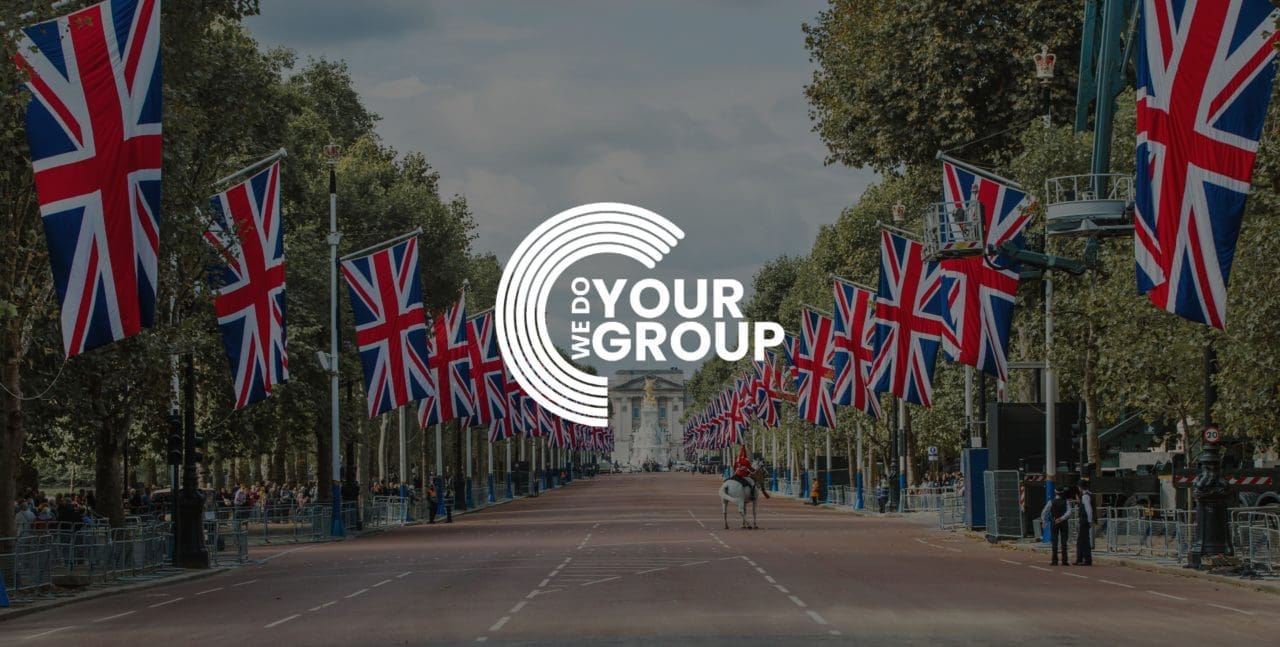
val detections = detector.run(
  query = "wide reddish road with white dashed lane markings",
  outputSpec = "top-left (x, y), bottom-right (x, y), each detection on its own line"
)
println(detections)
top-left (0, 473), bottom-right (1280, 647)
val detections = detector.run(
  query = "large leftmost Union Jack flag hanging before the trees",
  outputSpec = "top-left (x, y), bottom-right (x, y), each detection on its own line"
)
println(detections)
top-left (14, 0), bottom-right (161, 357)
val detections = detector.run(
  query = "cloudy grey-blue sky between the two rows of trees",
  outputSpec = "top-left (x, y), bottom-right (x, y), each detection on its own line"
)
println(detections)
top-left (246, 0), bottom-right (876, 374)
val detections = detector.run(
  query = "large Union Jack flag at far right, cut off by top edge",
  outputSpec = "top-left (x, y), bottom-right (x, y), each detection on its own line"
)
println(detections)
top-left (1134, 0), bottom-right (1276, 328)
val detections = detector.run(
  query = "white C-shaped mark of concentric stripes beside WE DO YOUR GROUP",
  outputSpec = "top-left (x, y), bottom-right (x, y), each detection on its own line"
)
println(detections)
top-left (494, 202), bottom-right (685, 427)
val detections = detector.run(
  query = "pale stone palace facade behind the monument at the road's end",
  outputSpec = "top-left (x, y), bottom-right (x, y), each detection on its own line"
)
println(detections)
top-left (609, 368), bottom-right (689, 465)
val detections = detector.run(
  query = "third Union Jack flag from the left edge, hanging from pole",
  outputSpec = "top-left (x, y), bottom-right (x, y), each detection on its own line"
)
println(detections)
top-left (342, 237), bottom-right (435, 418)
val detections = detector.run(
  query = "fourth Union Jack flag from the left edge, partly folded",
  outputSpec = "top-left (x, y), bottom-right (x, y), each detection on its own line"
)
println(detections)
top-left (417, 292), bottom-right (474, 427)
